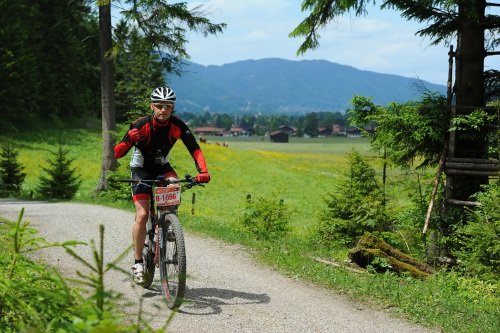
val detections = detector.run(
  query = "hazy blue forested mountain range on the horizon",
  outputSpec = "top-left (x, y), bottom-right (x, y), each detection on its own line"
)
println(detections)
top-left (167, 58), bottom-right (446, 114)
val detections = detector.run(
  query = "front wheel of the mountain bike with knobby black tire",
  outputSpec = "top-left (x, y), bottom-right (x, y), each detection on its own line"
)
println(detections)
top-left (158, 213), bottom-right (186, 310)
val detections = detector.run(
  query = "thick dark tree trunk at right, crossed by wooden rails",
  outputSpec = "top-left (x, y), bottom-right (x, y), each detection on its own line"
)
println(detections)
top-left (450, 0), bottom-right (488, 200)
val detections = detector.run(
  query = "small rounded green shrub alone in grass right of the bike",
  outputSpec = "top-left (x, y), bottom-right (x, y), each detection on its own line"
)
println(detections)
top-left (242, 193), bottom-right (290, 240)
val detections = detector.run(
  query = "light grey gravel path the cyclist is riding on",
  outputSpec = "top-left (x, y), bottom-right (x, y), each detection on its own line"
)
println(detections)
top-left (0, 200), bottom-right (430, 333)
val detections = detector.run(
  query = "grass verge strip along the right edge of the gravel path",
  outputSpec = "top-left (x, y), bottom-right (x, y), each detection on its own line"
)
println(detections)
top-left (181, 212), bottom-right (500, 333)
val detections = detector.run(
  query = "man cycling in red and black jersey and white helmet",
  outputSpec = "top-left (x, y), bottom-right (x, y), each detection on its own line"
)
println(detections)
top-left (114, 86), bottom-right (210, 284)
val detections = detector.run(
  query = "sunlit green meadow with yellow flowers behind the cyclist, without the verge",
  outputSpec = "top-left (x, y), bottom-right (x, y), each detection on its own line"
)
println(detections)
top-left (9, 130), bottom-right (376, 230)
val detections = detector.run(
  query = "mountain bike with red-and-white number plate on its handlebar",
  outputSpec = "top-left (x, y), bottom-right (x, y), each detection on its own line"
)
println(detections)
top-left (120, 175), bottom-right (203, 310)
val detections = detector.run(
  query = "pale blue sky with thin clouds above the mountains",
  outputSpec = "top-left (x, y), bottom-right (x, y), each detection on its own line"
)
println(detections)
top-left (183, 0), bottom-right (500, 85)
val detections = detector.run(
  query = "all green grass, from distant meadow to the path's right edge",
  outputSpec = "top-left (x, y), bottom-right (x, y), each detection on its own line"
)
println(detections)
top-left (2, 130), bottom-right (500, 332)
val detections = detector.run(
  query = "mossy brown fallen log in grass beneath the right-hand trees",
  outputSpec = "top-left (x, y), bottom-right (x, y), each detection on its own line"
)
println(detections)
top-left (349, 233), bottom-right (434, 278)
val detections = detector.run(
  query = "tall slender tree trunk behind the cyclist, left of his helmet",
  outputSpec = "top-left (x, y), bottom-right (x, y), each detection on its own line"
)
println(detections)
top-left (96, 0), bottom-right (116, 191)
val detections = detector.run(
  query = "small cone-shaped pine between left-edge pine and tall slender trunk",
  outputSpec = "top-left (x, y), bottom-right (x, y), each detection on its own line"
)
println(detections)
top-left (38, 145), bottom-right (81, 200)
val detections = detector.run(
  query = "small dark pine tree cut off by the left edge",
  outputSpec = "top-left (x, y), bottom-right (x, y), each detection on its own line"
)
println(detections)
top-left (0, 143), bottom-right (26, 197)
